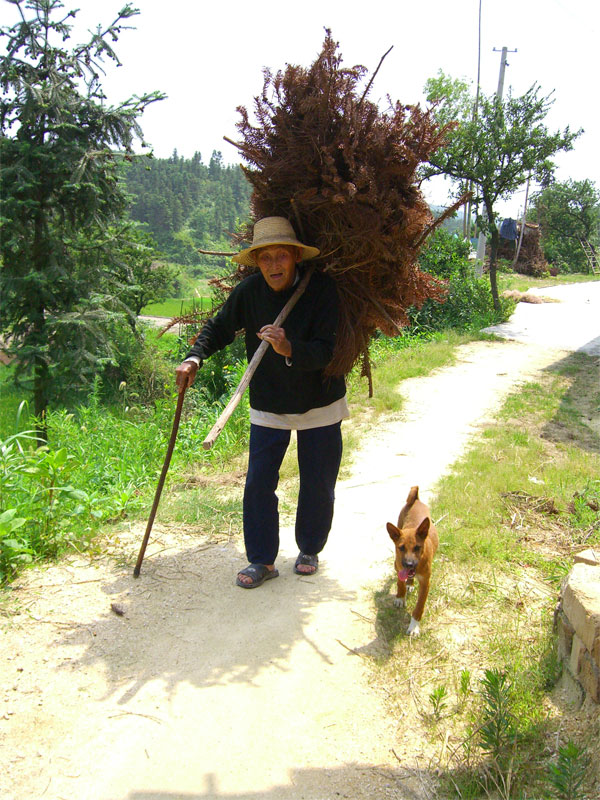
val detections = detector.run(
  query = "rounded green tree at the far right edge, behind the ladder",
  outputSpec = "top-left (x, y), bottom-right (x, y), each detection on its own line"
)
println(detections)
top-left (529, 180), bottom-right (600, 272)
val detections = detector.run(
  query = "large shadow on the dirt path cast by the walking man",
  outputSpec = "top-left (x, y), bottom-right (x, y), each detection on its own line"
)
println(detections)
top-left (51, 545), bottom-right (353, 704)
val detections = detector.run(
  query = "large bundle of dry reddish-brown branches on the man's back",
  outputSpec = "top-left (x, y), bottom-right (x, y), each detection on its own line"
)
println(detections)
top-left (180, 31), bottom-right (466, 388)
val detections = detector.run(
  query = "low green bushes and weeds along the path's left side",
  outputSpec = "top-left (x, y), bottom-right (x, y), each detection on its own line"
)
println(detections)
top-left (0, 374), bottom-right (248, 583)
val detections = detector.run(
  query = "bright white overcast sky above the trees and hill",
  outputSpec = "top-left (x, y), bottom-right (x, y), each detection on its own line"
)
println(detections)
top-left (0, 0), bottom-right (600, 217)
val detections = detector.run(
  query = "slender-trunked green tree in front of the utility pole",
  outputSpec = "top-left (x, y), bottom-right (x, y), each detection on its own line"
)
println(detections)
top-left (425, 74), bottom-right (581, 311)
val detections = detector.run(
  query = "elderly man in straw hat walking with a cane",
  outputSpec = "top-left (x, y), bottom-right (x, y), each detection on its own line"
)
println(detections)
top-left (176, 217), bottom-right (348, 589)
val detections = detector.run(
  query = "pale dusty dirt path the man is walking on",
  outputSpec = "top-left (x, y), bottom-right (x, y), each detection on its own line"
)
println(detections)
top-left (0, 285), bottom-right (600, 800)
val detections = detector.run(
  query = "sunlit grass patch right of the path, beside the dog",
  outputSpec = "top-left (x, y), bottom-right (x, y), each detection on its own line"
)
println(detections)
top-left (375, 354), bottom-right (600, 800)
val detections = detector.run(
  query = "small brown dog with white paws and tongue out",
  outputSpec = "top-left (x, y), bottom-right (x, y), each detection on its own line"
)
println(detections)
top-left (387, 486), bottom-right (439, 636)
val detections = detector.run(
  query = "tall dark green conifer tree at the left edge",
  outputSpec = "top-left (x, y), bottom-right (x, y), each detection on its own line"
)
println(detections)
top-left (0, 0), bottom-right (162, 437)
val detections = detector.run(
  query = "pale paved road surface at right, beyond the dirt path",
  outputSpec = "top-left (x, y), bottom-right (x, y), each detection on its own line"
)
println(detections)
top-left (485, 281), bottom-right (600, 355)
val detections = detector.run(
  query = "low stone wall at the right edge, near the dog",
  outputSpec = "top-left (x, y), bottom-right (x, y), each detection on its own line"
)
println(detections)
top-left (555, 550), bottom-right (600, 704)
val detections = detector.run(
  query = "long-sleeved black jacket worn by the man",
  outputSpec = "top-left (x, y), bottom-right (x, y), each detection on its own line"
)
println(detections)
top-left (188, 267), bottom-right (346, 414)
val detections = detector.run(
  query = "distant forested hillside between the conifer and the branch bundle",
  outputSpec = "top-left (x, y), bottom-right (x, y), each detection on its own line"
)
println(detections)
top-left (125, 150), bottom-right (250, 267)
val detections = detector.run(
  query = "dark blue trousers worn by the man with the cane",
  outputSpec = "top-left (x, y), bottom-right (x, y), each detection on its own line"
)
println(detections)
top-left (244, 422), bottom-right (342, 564)
